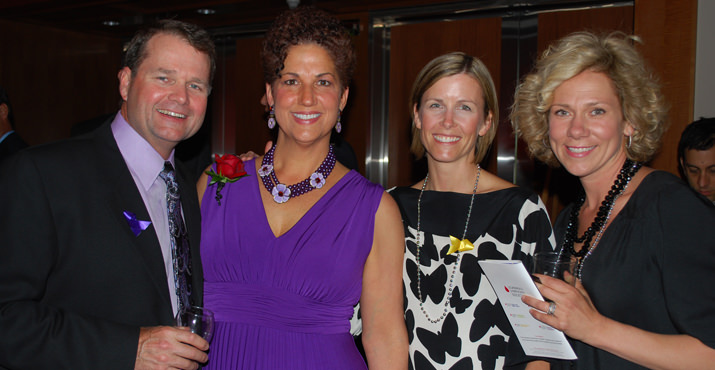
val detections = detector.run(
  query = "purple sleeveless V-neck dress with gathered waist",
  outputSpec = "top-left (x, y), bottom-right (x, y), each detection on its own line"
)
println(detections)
top-left (201, 160), bottom-right (383, 370)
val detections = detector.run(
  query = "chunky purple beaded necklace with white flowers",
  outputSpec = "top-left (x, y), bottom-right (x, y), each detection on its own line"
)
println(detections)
top-left (258, 145), bottom-right (335, 204)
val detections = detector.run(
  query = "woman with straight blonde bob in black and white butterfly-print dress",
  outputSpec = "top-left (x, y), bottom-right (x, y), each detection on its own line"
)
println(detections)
top-left (391, 53), bottom-right (554, 369)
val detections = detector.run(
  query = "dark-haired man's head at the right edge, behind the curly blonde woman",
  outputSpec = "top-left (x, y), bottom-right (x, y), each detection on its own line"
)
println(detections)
top-left (678, 118), bottom-right (715, 204)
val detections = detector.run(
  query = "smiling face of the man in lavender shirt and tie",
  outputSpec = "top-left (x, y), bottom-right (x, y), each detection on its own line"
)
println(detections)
top-left (119, 33), bottom-right (210, 159)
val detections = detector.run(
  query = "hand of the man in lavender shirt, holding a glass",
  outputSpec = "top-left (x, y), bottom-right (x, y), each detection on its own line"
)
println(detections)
top-left (134, 326), bottom-right (209, 370)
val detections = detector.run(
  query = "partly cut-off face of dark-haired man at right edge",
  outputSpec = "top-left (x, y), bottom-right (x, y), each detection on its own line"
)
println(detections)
top-left (681, 146), bottom-right (715, 202)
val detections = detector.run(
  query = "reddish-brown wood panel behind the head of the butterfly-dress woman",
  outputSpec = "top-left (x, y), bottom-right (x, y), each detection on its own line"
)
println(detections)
top-left (387, 18), bottom-right (501, 187)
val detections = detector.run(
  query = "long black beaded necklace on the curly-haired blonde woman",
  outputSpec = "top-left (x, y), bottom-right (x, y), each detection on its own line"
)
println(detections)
top-left (562, 159), bottom-right (643, 277)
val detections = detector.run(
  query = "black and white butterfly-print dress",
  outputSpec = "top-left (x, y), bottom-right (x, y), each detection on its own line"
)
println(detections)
top-left (390, 187), bottom-right (554, 370)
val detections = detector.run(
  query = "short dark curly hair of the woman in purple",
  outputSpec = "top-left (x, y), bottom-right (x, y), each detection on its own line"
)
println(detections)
top-left (261, 6), bottom-right (355, 89)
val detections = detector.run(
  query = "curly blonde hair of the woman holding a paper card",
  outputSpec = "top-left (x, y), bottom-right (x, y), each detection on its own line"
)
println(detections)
top-left (510, 32), bottom-right (667, 166)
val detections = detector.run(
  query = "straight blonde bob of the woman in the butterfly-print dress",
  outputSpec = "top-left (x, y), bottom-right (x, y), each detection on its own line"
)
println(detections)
top-left (410, 52), bottom-right (499, 164)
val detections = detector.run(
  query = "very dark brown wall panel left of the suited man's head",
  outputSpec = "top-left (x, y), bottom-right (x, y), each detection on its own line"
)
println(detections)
top-left (0, 21), bottom-right (121, 145)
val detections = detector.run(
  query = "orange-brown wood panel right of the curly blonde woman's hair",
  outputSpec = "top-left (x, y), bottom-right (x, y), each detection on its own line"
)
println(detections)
top-left (635, 0), bottom-right (698, 175)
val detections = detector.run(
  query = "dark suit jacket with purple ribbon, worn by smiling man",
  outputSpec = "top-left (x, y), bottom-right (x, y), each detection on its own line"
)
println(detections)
top-left (0, 123), bottom-right (203, 370)
